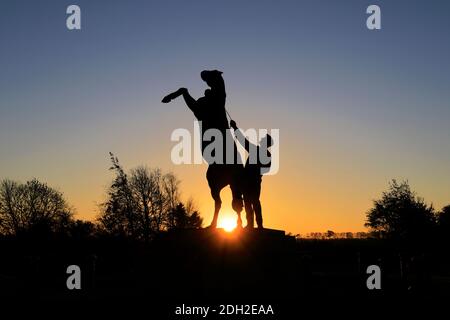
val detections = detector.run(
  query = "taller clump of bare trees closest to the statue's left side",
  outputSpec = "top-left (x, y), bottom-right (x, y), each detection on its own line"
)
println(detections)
top-left (98, 154), bottom-right (202, 241)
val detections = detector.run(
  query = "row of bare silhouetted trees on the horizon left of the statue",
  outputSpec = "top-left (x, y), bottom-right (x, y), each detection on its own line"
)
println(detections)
top-left (0, 153), bottom-right (203, 242)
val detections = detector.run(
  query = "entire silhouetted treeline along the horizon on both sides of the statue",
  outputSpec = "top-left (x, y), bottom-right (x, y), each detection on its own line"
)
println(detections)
top-left (0, 168), bottom-right (450, 246)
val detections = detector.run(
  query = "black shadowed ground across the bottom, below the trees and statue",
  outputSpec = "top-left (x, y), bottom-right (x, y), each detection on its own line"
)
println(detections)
top-left (0, 229), bottom-right (450, 319)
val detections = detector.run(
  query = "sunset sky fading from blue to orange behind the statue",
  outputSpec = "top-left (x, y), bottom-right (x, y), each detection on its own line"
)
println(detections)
top-left (0, 0), bottom-right (450, 233)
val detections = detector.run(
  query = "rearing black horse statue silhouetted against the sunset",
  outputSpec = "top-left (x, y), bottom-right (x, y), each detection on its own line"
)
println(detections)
top-left (162, 70), bottom-right (243, 228)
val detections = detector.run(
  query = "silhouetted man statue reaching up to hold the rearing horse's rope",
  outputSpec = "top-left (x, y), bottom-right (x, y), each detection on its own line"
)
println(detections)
top-left (230, 120), bottom-right (273, 229)
